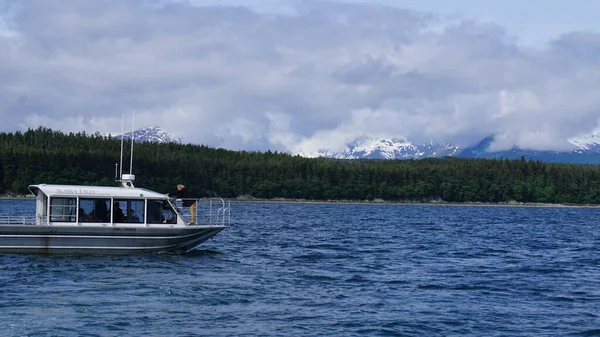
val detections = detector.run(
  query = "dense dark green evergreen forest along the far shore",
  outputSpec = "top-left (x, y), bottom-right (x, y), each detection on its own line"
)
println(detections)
top-left (0, 128), bottom-right (600, 205)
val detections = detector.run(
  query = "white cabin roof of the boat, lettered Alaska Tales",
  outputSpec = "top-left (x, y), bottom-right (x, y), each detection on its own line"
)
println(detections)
top-left (29, 184), bottom-right (169, 199)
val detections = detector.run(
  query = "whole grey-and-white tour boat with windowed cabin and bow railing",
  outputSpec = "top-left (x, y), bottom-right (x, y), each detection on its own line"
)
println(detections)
top-left (0, 174), bottom-right (231, 254)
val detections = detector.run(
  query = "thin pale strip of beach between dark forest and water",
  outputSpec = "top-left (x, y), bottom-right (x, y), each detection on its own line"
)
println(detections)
top-left (0, 195), bottom-right (600, 208)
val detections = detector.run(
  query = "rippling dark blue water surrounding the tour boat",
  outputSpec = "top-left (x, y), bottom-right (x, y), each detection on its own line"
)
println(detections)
top-left (0, 200), bottom-right (600, 336)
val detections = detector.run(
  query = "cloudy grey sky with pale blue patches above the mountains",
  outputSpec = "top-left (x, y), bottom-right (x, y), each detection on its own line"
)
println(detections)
top-left (0, 0), bottom-right (600, 155)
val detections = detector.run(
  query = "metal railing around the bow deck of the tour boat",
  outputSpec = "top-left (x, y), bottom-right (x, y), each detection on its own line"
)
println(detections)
top-left (171, 198), bottom-right (231, 226)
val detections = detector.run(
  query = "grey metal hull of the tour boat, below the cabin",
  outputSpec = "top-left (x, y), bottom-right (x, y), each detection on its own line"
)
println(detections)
top-left (0, 225), bottom-right (228, 254)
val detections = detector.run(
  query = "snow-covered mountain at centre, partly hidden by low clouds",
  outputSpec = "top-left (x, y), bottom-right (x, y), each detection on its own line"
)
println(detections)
top-left (320, 138), bottom-right (460, 159)
